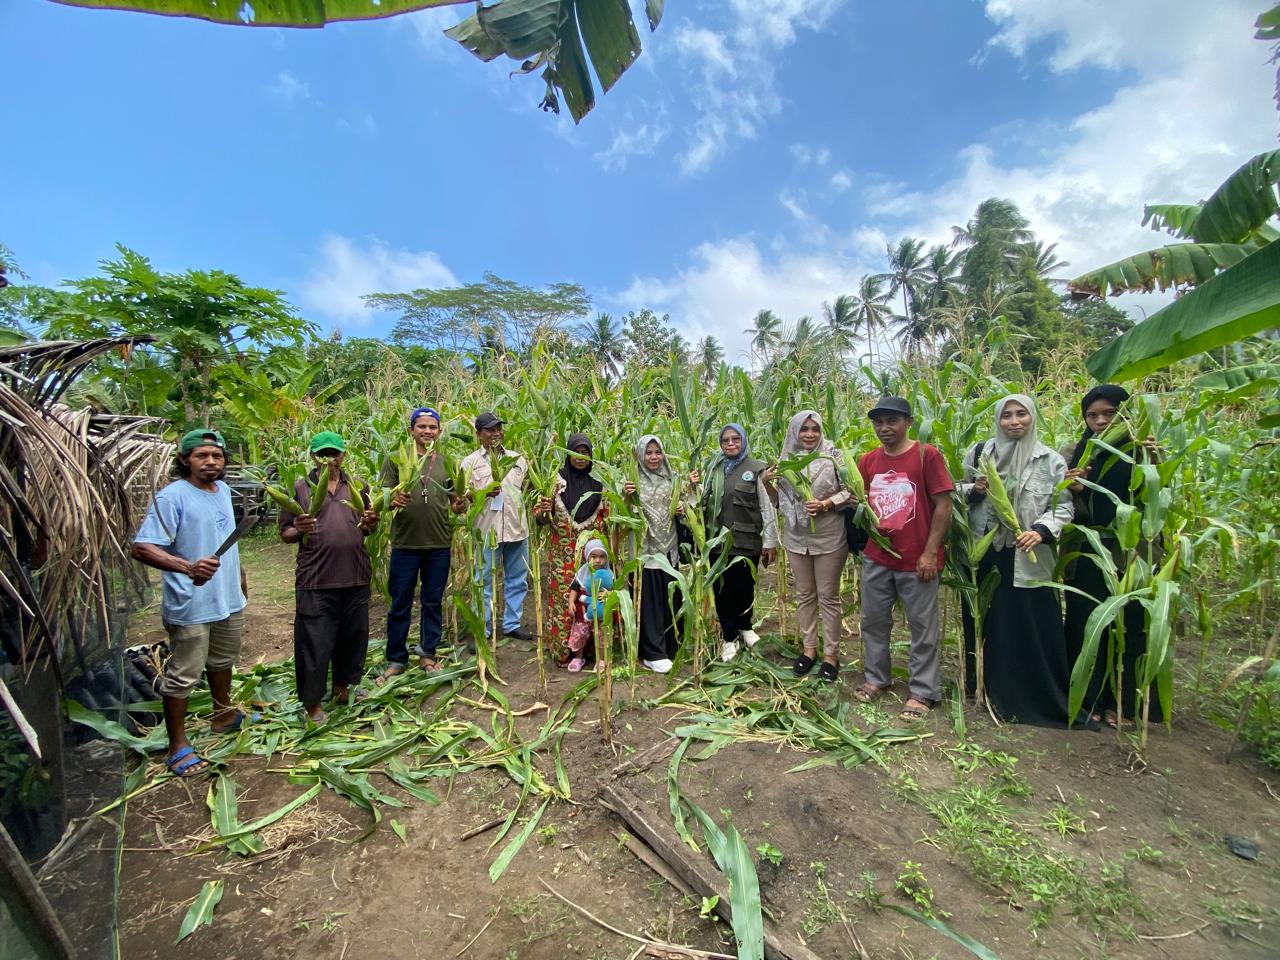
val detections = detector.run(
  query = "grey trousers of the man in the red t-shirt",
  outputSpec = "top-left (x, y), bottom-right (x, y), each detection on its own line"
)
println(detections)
top-left (863, 557), bottom-right (942, 704)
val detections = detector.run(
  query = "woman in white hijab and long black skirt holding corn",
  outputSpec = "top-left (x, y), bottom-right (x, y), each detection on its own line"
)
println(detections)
top-left (960, 393), bottom-right (1074, 727)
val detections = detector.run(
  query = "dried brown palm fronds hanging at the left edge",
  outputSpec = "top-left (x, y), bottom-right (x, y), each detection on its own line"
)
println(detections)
top-left (0, 338), bottom-right (172, 686)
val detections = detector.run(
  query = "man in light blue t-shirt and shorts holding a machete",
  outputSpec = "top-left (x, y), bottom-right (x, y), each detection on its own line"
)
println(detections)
top-left (131, 430), bottom-right (248, 777)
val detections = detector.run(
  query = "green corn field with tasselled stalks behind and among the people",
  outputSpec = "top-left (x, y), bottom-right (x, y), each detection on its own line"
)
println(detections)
top-left (222, 337), bottom-right (1280, 744)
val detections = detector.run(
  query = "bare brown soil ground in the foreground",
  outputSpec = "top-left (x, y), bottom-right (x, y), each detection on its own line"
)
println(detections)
top-left (45, 541), bottom-right (1280, 960)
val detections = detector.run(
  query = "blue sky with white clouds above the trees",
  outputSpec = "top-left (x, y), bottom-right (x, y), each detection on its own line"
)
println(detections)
top-left (0, 0), bottom-right (1277, 363)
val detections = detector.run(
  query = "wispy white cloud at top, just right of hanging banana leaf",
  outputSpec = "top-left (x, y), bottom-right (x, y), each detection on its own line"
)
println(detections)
top-left (673, 0), bottom-right (844, 175)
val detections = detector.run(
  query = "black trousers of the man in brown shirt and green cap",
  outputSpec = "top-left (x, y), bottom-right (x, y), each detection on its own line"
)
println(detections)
top-left (293, 584), bottom-right (369, 707)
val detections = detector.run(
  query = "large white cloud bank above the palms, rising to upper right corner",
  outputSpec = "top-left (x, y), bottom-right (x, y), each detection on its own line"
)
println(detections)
top-left (611, 0), bottom-right (1276, 357)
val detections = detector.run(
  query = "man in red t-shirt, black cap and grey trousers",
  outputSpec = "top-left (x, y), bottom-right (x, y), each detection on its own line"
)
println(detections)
top-left (856, 397), bottom-right (955, 719)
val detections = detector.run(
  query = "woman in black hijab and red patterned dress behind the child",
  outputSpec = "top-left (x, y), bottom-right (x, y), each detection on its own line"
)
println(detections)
top-left (535, 434), bottom-right (609, 664)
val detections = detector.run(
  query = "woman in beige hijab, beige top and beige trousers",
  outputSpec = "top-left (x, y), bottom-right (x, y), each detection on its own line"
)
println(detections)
top-left (777, 410), bottom-right (850, 680)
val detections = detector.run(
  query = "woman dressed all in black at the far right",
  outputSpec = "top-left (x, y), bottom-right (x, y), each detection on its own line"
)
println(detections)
top-left (1064, 384), bottom-right (1164, 727)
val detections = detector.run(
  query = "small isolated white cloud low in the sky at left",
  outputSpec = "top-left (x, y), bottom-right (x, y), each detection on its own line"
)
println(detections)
top-left (298, 234), bottom-right (457, 326)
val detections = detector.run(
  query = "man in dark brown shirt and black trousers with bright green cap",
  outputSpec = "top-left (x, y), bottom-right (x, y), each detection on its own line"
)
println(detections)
top-left (280, 430), bottom-right (378, 723)
